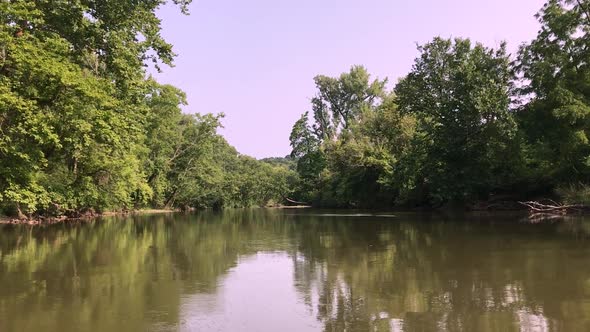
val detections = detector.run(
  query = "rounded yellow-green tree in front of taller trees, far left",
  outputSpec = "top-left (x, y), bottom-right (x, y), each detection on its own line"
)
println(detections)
top-left (0, 24), bottom-right (149, 212)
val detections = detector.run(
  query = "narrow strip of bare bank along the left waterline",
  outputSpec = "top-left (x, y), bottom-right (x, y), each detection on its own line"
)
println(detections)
top-left (0, 209), bottom-right (180, 225)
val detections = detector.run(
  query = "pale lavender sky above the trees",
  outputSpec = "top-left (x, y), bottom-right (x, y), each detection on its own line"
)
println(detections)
top-left (154, 0), bottom-right (545, 158)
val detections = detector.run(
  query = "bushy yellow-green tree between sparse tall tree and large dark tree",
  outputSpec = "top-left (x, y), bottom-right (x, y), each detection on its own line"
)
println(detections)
top-left (322, 95), bottom-right (415, 207)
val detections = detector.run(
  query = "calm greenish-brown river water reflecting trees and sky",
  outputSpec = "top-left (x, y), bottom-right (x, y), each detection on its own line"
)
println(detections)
top-left (0, 209), bottom-right (590, 332)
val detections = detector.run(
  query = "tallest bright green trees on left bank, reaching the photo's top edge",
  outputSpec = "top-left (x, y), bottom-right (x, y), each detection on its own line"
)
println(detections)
top-left (0, 0), bottom-right (189, 215)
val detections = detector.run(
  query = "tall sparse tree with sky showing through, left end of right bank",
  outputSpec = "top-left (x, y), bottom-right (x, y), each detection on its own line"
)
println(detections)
top-left (290, 66), bottom-right (387, 201)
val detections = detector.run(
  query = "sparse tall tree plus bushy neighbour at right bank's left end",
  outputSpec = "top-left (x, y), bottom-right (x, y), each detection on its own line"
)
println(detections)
top-left (290, 66), bottom-right (413, 206)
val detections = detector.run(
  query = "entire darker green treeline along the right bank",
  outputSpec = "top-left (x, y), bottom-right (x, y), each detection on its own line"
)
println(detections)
top-left (290, 0), bottom-right (590, 207)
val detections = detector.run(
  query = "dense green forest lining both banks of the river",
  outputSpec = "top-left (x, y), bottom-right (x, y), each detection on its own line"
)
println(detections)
top-left (0, 0), bottom-right (590, 218)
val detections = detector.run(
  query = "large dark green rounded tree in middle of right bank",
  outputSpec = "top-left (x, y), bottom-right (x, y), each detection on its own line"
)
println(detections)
top-left (395, 38), bottom-right (516, 202)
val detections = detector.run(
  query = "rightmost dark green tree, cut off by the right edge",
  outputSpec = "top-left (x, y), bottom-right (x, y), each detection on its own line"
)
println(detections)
top-left (515, 0), bottom-right (590, 185)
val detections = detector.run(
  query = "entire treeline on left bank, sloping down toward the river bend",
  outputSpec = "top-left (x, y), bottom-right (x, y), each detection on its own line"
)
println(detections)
top-left (0, 0), bottom-right (294, 217)
